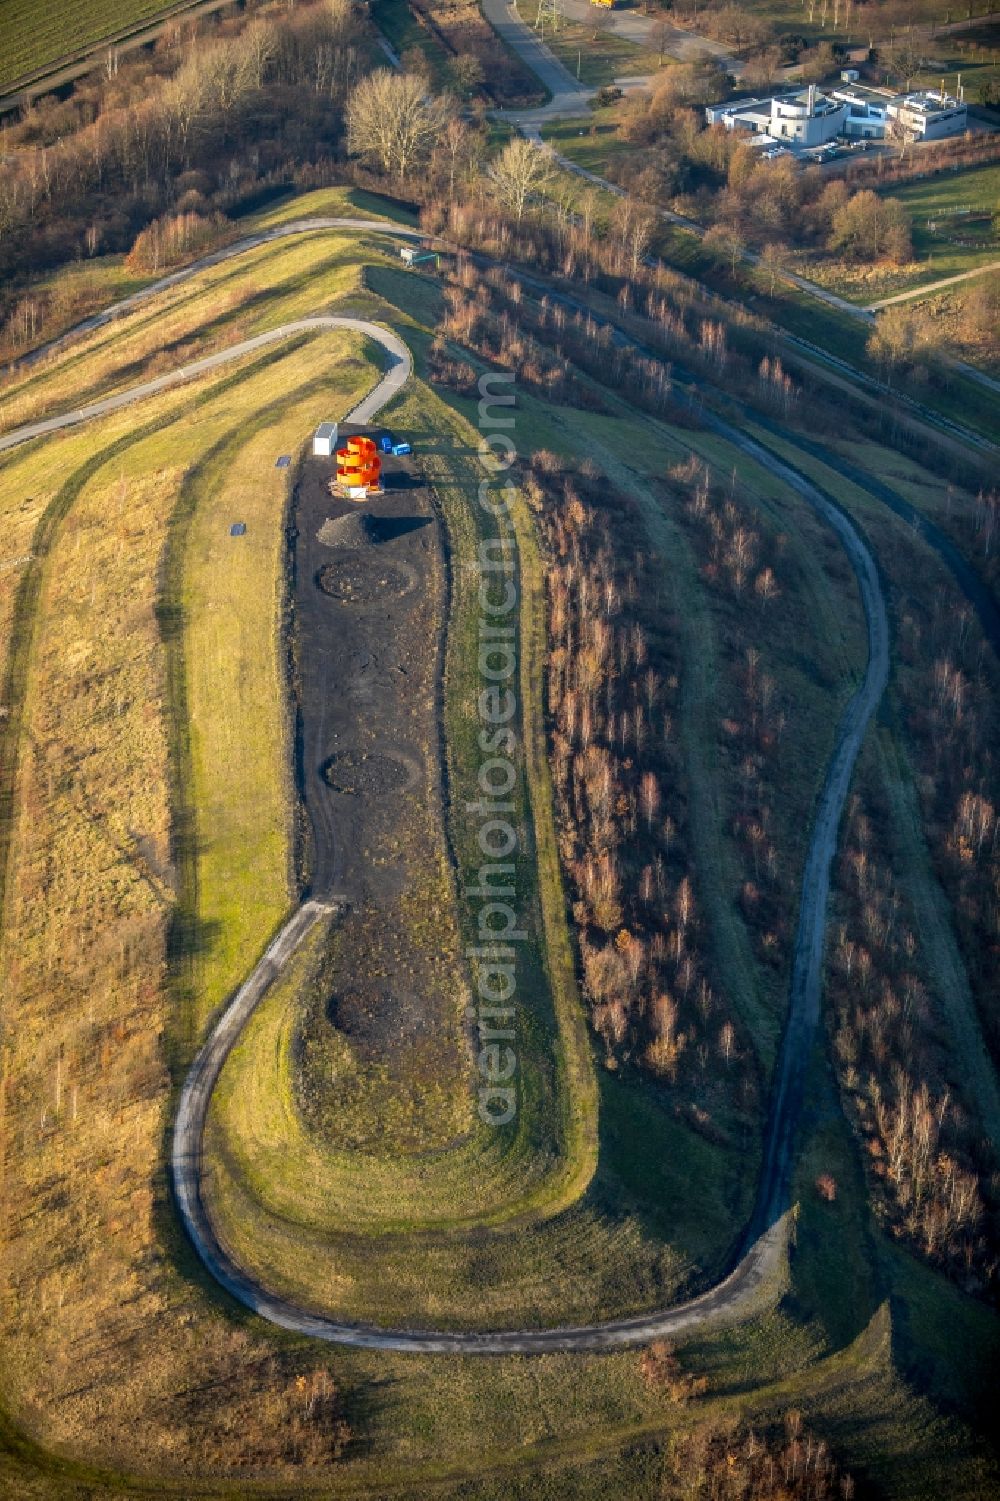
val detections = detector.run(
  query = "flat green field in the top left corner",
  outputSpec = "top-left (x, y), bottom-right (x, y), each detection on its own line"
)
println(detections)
top-left (0, 0), bottom-right (189, 89)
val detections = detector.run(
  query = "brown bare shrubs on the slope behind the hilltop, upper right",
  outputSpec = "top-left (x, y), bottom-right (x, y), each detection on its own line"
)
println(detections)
top-left (420, 192), bottom-right (846, 438)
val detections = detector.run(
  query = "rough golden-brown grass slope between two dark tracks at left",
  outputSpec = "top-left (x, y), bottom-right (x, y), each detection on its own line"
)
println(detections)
top-left (3, 417), bottom-right (347, 1471)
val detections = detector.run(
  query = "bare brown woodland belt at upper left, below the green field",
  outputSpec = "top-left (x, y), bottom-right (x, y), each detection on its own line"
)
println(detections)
top-left (0, 0), bottom-right (363, 328)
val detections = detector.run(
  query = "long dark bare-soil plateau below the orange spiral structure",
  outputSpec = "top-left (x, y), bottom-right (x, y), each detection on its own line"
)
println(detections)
top-left (286, 432), bottom-right (467, 1151)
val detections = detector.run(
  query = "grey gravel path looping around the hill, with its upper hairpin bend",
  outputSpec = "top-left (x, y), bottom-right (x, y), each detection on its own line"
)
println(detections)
top-left (0, 255), bottom-right (889, 1354)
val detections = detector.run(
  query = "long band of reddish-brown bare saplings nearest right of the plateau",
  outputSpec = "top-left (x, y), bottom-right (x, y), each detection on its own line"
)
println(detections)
top-left (524, 453), bottom-right (757, 1132)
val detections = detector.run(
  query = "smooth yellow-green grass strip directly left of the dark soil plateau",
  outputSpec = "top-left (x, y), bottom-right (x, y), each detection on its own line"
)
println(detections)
top-left (164, 332), bottom-right (377, 1042)
